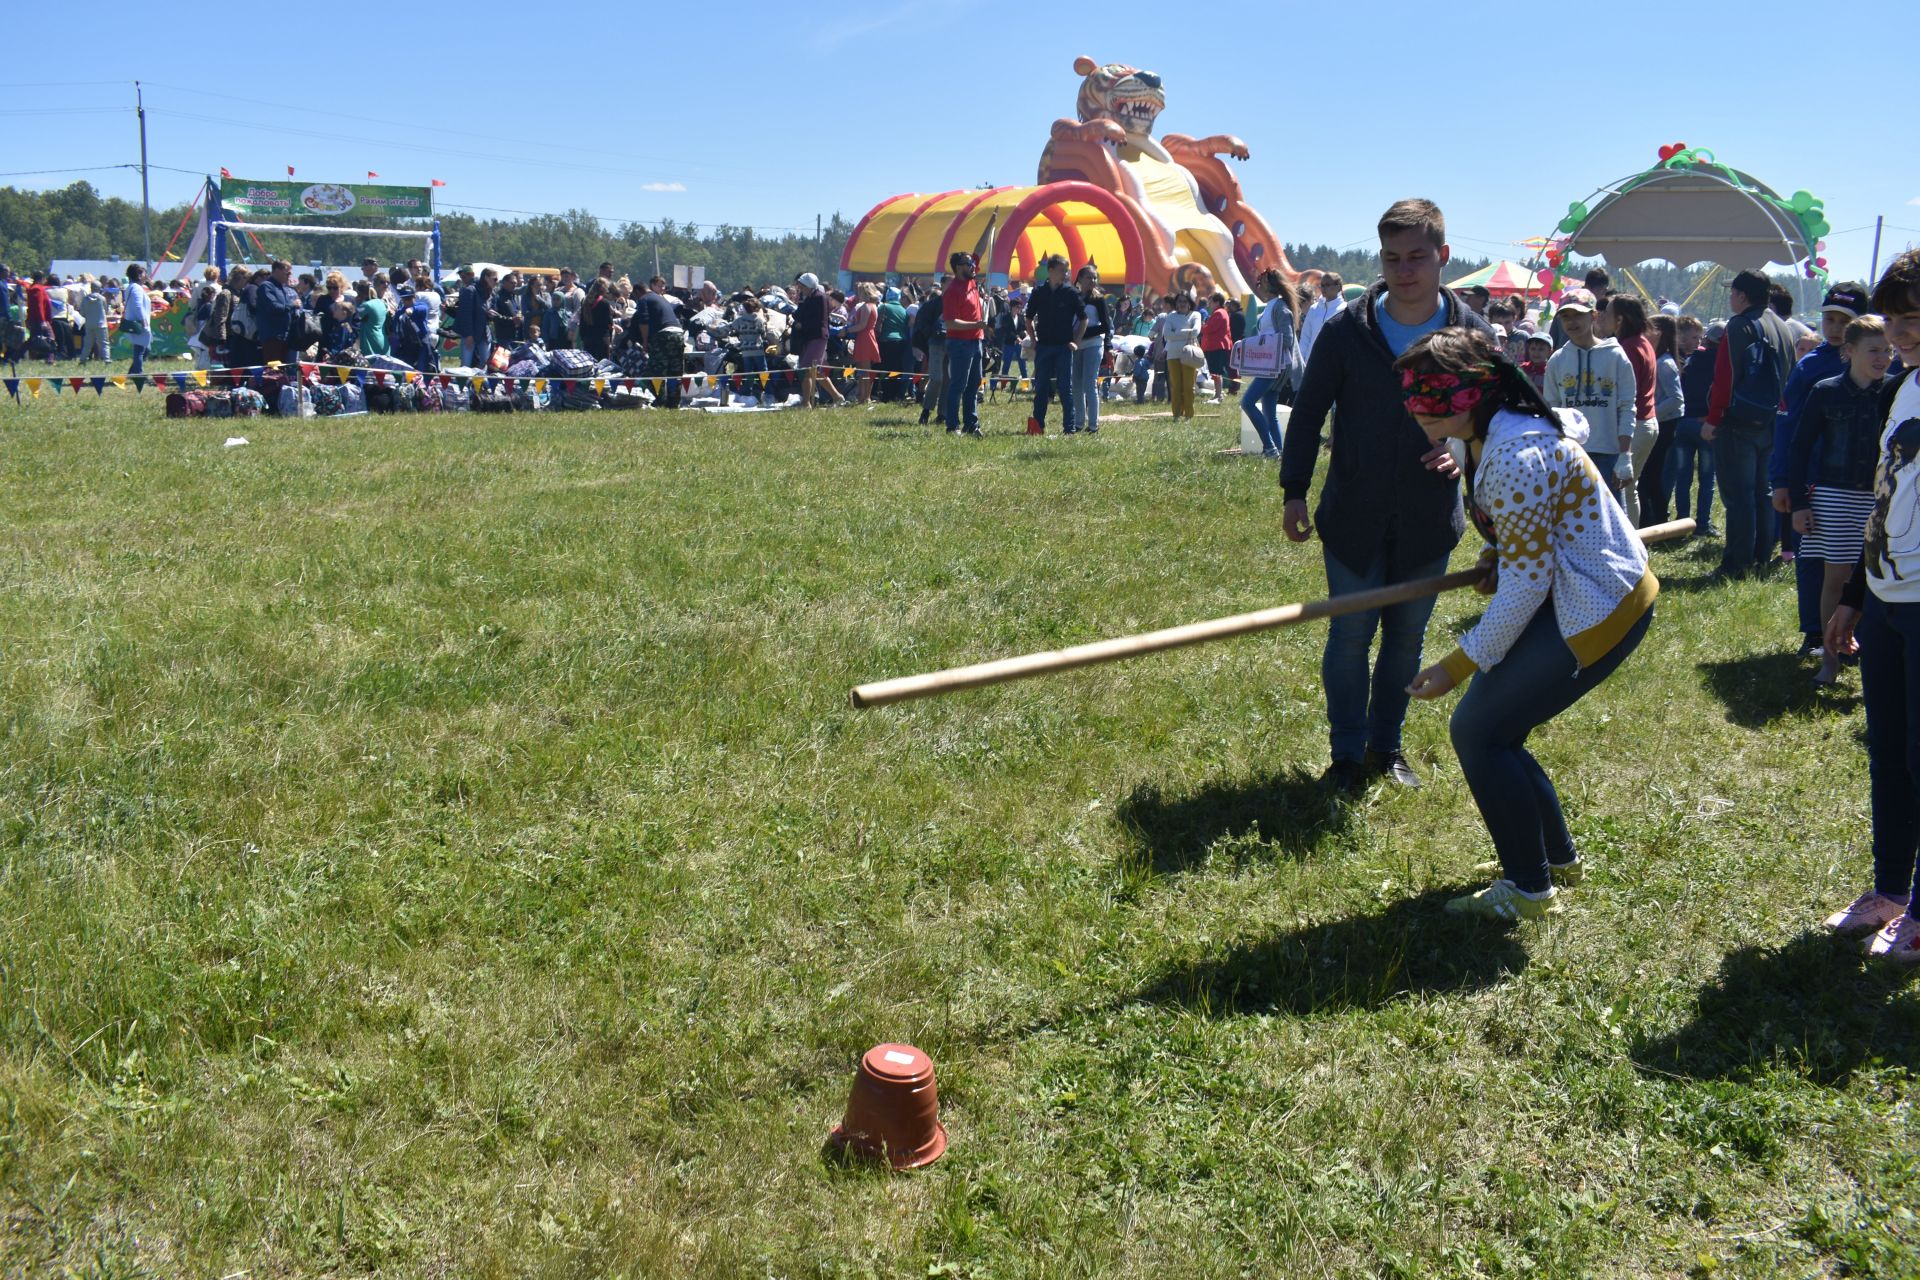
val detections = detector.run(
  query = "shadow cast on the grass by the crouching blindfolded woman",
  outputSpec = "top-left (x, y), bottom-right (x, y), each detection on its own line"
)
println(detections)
top-left (1135, 887), bottom-right (1526, 1017)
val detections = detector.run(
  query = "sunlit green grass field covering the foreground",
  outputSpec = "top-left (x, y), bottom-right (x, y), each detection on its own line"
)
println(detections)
top-left (0, 362), bottom-right (1920, 1280)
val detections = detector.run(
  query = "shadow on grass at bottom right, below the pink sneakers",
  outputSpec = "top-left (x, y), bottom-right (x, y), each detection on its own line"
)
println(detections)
top-left (1634, 931), bottom-right (1920, 1086)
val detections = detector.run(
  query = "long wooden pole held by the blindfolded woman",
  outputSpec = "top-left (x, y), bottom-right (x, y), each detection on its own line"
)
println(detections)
top-left (851, 520), bottom-right (1693, 710)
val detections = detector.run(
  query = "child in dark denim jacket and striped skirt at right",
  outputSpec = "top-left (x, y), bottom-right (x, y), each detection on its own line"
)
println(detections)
top-left (1788, 315), bottom-right (1893, 685)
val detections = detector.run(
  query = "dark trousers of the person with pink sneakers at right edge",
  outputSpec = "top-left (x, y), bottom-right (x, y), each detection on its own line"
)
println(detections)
top-left (1855, 589), bottom-right (1920, 898)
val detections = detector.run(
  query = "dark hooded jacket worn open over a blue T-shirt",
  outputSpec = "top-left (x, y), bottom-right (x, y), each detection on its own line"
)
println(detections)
top-left (1281, 284), bottom-right (1494, 578)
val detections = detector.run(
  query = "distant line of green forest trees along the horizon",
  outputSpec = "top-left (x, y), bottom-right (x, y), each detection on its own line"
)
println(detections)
top-left (0, 182), bottom-right (1818, 315)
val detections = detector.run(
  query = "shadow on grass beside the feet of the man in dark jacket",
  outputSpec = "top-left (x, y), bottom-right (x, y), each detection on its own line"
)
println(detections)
top-left (1114, 766), bottom-right (1354, 875)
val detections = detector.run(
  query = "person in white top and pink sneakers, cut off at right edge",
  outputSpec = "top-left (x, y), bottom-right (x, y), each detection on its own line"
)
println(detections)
top-left (1824, 249), bottom-right (1920, 965)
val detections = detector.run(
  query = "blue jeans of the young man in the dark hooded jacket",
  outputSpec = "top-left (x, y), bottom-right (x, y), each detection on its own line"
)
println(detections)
top-left (1320, 541), bottom-right (1448, 760)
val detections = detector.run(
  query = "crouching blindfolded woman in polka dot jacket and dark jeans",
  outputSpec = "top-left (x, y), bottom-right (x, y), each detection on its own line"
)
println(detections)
top-left (1394, 330), bottom-right (1659, 919)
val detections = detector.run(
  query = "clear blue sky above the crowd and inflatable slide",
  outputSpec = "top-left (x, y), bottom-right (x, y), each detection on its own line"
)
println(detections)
top-left (0, 0), bottom-right (1920, 285)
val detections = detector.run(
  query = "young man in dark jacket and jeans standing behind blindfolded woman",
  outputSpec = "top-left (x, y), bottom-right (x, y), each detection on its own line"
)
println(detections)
top-left (1281, 200), bottom-right (1492, 791)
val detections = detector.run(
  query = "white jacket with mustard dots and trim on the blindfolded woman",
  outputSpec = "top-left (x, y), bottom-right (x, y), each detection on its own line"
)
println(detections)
top-left (1440, 411), bottom-right (1661, 681)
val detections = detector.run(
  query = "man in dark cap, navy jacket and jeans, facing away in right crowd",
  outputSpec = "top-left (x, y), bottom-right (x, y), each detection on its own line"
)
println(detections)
top-left (1699, 271), bottom-right (1793, 578)
